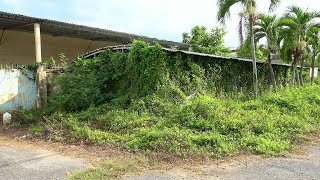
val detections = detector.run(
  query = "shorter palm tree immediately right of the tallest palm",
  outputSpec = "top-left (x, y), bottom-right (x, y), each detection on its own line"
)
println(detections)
top-left (254, 14), bottom-right (278, 91)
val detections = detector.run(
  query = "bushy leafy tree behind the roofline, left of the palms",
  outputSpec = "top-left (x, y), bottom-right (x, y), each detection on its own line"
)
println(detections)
top-left (182, 26), bottom-right (231, 56)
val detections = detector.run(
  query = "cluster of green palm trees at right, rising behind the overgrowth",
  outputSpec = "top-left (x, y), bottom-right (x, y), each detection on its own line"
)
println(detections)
top-left (217, 0), bottom-right (320, 97)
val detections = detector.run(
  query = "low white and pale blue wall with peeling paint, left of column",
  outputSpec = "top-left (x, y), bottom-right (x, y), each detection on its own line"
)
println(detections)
top-left (0, 69), bottom-right (37, 114)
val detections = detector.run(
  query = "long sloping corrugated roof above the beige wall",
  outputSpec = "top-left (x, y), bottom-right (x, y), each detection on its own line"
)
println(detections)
top-left (0, 11), bottom-right (187, 47)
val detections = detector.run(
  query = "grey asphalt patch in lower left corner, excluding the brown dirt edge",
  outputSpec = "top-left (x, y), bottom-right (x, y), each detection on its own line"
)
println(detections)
top-left (0, 147), bottom-right (88, 180)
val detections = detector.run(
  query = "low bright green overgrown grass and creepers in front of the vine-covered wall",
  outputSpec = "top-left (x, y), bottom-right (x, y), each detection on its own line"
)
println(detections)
top-left (24, 85), bottom-right (320, 157)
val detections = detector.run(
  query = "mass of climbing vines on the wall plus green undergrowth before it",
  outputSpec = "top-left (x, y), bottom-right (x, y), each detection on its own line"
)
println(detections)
top-left (23, 42), bottom-right (320, 157)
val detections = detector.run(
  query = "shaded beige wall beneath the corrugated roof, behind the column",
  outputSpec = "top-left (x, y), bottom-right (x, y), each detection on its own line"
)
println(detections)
top-left (0, 30), bottom-right (119, 64)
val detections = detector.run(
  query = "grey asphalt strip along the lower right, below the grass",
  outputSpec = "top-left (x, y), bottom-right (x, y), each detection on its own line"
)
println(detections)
top-left (127, 147), bottom-right (320, 180)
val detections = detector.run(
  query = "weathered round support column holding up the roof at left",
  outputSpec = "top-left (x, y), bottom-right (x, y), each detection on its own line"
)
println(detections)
top-left (34, 23), bottom-right (47, 108)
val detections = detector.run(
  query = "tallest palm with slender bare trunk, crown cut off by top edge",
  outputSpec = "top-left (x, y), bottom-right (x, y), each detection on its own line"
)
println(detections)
top-left (217, 0), bottom-right (280, 97)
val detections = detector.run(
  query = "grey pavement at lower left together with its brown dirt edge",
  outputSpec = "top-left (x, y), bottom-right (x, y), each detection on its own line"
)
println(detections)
top-left (0, 129), bottom-right (89, 180)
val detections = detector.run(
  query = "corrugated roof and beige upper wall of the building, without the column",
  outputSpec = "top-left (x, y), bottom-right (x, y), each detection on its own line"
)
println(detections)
top-left (0, 12), bottom-right (182, 65)
